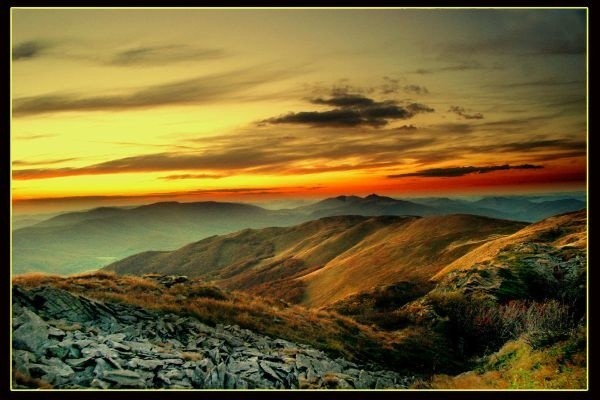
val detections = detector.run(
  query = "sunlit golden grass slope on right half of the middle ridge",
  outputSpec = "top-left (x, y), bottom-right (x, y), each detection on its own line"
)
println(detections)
top-left (301, 215), bottom-right (524, 307)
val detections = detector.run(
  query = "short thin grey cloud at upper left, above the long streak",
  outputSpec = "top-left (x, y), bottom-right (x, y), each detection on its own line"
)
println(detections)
top-left (109, 45), bottom-right (225, 66)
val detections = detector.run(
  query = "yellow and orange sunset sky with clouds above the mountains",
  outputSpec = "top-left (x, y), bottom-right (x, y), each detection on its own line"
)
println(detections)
top-left (11, 8), bottom-right (587, 212)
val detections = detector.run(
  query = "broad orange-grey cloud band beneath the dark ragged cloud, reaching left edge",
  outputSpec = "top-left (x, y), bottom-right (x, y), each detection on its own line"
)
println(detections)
top-left (13, 127), bottom-right (436, 180)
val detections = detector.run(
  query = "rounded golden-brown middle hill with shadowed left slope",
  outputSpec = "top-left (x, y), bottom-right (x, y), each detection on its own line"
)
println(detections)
top-left (105, 215), bottom-right (526, 306)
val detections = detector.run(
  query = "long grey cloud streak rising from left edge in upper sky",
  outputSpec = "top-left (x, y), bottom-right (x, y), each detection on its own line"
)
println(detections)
top-left (13, 67), bottom-right (297, 116)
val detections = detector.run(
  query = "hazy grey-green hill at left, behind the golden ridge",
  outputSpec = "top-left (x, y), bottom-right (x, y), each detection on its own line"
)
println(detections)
top-left (12, 202), bottom-right (298, 274)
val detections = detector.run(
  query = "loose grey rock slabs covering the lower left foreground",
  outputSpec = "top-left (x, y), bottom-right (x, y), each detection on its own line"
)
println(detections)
top-left (12, 287), bottom-right (410, 389)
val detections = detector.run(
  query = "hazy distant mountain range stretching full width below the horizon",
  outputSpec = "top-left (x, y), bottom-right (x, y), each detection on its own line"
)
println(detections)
top-left (12, 195), bottom-right (585, 274)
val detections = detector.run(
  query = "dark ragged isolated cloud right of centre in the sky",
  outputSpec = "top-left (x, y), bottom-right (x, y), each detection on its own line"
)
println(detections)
top-left (260, 93), bottom-right (434, 127)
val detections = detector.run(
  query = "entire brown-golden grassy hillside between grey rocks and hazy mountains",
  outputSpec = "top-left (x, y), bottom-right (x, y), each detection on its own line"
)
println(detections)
top-left (13, 212), bottom-right (588, 389)
